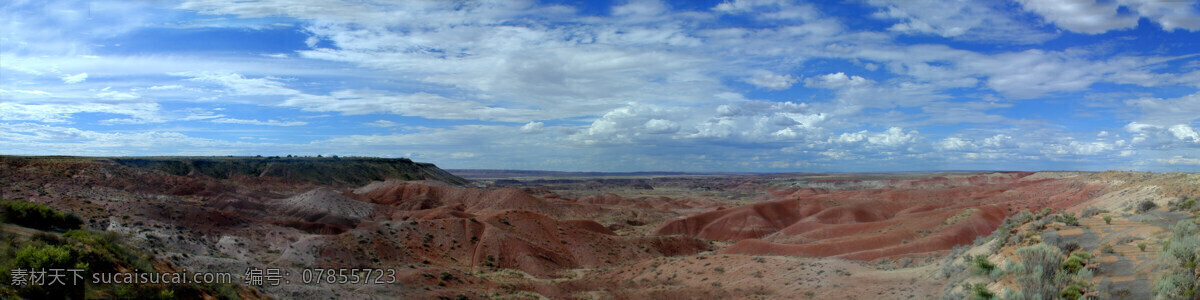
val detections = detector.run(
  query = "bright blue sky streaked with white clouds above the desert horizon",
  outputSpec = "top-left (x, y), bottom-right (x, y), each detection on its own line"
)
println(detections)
top-left (0, 0), bottom-right (1200, 172)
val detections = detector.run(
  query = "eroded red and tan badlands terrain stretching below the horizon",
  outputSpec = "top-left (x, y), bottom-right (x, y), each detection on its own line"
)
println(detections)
top-left (0, 156), bottom-right (1200, 299)
